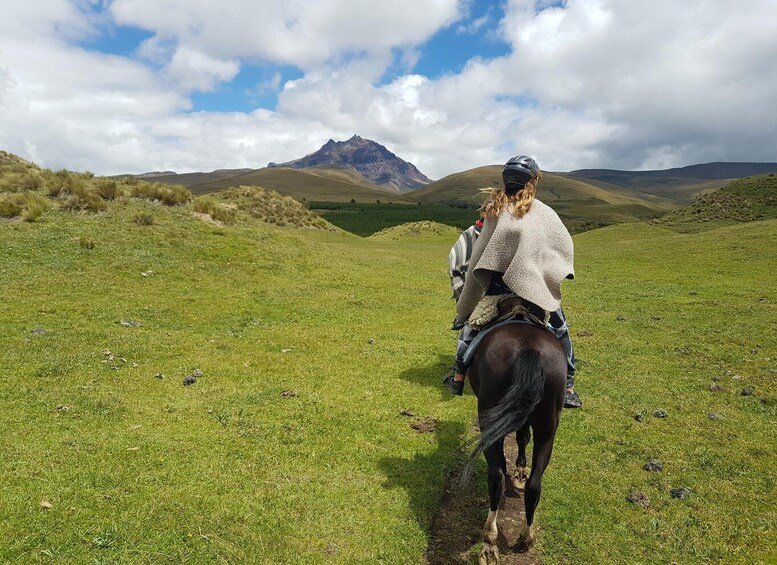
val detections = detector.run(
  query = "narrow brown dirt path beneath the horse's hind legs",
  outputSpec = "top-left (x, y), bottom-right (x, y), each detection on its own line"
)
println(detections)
top-left (425, 434), bottom-right (540, 565)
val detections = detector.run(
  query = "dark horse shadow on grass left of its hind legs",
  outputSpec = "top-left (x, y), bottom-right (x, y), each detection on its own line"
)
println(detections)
top-left (380, 416), bottom-right (488, 565)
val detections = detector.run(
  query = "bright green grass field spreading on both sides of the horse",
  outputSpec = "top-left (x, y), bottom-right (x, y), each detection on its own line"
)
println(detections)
top-left (0, 194), bottom-right (777, 564)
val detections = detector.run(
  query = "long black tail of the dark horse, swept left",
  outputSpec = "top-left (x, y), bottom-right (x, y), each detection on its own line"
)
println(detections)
top-left (459, 349), bottom-right (545, 484)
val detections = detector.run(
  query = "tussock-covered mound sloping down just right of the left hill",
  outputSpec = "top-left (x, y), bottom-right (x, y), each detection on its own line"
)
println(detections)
top-left (221, 186), bottom-right (335, 231)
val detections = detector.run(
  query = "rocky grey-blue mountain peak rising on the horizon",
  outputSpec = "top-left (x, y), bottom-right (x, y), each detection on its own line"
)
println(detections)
top-left (267, 135), bottom-right (431, 193)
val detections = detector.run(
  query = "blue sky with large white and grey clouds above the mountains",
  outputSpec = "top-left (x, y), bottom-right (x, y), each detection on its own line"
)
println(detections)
top-left (0, 0), bottom-right (777, 178)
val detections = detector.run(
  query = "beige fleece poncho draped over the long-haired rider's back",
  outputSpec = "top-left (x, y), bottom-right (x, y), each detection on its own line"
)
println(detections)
top-left (456, 199), bottom-right (575, 321)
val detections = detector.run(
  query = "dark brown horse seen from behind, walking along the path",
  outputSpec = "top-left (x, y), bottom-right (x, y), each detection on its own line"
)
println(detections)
top-left (461, 323), bottom-right (567, 565)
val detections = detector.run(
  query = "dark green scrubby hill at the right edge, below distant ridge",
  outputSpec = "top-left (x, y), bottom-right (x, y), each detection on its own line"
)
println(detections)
top-left (655, 173), bottom-right (777, 232)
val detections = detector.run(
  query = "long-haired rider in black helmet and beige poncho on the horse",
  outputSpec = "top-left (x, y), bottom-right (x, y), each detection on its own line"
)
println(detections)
top-left (443, 156), bottom-right (582, 408)
